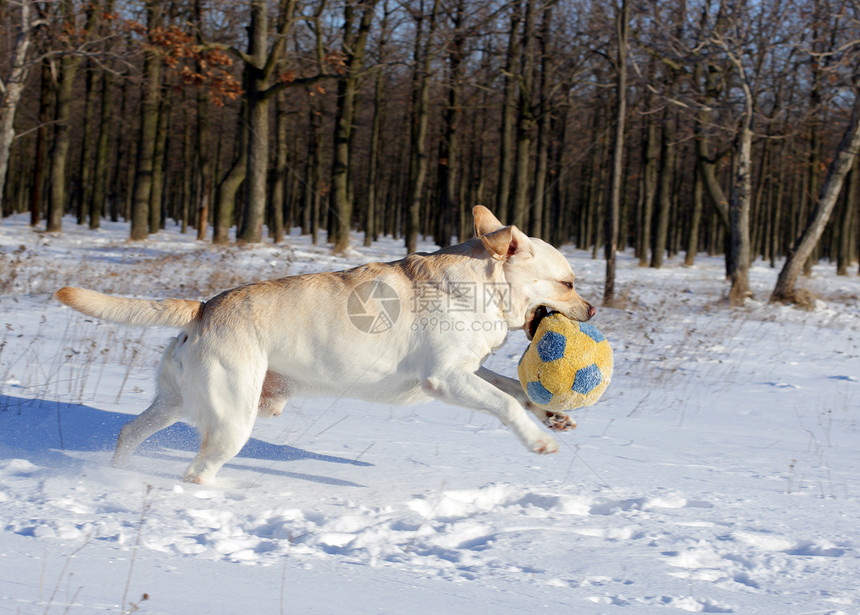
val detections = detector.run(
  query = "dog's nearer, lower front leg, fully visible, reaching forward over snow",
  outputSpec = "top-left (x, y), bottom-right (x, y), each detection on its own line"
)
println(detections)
top-left (422, 371), bottom-right (558, 453)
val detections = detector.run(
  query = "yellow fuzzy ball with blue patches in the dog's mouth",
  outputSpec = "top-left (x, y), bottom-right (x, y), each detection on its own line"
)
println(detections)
top-left (517, 313), bottom-right (612, 410)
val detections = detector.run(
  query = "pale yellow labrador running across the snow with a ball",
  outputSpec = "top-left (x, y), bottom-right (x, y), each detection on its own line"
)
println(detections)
top-left (56, 206), bottom-right (595, 483)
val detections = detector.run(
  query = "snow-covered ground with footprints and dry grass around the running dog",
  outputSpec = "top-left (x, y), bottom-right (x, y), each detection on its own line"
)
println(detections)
top-left (0, 217), bottom-right (860, 615)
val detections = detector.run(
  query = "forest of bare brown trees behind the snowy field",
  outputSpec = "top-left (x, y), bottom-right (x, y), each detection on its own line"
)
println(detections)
top-left (0, 0), bottom-right (860, 304)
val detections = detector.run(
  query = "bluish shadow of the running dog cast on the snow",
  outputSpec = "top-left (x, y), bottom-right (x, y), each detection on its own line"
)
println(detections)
top-left (0, 395), bottom-right (373, 487)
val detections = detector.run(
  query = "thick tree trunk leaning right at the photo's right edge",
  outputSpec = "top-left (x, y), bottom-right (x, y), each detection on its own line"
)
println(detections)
top-left (770, 91), bottom-right (860, 303)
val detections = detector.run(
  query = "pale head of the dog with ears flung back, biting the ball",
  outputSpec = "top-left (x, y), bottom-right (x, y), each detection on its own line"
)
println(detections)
top-left (473, 205), bottom-right (596, 339)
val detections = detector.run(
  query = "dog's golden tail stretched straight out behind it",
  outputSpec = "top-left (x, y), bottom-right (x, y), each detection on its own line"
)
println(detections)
top-left (54, 286), bottom-right (203, 329)
